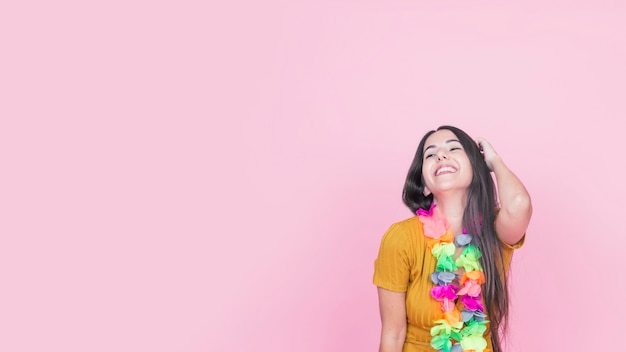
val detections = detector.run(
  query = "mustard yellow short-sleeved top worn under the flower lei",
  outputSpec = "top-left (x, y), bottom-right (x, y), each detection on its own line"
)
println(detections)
top-left (374, 216), bottom-right (525, 352)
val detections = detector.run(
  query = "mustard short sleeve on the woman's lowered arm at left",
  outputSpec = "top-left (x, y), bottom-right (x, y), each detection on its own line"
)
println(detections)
top-left (373, 224), bottom-right (411, 292)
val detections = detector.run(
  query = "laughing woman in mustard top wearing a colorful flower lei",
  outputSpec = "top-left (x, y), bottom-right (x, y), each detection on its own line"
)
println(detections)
top-left (374, 126), bottom-right (532, 352)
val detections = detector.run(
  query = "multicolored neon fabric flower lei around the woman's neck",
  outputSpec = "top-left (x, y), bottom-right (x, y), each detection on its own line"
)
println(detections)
top-left (417, 203), bottom-right (489, 352)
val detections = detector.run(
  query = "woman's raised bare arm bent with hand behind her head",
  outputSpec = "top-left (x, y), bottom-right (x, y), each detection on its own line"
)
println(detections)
top-left (477, 138), bottom-right (533, 245)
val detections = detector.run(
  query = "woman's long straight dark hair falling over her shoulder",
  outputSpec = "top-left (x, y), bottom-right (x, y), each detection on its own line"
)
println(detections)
top-left (402, 126), bottom-right (509, 352)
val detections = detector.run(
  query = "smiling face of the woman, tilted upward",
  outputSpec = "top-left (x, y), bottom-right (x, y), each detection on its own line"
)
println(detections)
top-left (422, 130), bottom-right (473, 196)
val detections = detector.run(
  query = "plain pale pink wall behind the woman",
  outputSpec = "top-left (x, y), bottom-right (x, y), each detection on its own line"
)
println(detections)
top-left (0, 0), bottom-right (626, 352)
